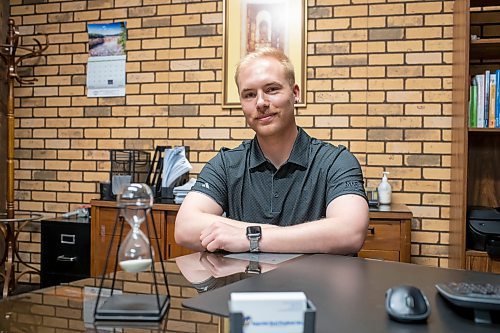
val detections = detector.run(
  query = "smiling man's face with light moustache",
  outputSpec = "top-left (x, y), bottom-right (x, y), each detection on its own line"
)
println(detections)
top-left (238, 58), bottom-right (299, 137)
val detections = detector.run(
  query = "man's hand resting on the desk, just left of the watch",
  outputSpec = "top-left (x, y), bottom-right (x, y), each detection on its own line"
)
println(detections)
top-left (200, 221), bottom-right (250, 252)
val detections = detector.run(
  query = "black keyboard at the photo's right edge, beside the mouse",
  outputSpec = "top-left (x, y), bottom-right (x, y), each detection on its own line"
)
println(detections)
top-left (436, 282), bottom-right (500, 324)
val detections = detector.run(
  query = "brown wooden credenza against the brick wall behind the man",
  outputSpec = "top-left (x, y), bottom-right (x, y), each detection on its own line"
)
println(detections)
top-left (90, 200), bottom-right (412, 276)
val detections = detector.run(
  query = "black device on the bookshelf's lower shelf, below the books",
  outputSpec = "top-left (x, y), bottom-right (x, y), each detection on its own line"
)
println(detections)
top-left (467, 207), bottom-right (500, 256)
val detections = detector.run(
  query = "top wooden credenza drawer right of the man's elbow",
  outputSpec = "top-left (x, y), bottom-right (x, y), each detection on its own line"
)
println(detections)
top-left (363, 220), bottom-right (401, 251)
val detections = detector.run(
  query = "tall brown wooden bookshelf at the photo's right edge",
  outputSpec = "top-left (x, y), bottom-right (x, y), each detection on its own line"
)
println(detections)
top-left (449, 0), bottom-right (500, 270)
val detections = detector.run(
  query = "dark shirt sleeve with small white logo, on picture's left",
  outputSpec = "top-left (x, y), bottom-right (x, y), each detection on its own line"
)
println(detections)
top-left (191, 150), bottom-right (228, 212)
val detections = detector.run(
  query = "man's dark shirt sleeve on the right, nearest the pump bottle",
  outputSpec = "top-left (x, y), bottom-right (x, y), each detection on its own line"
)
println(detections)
top-left (326, 146), bottom-right (368, 206)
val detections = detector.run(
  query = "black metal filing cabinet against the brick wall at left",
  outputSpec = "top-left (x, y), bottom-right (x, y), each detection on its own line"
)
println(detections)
top-left (40, 217), bottom-right (90, 288)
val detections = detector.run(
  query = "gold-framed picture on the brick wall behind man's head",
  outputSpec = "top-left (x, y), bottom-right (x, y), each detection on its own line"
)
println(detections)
top-left (222, 0), bottom-right (307, 108)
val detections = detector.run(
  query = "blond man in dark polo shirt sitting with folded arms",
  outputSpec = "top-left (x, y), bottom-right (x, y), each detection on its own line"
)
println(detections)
top-left (175, 48), bottom-right (368, 254)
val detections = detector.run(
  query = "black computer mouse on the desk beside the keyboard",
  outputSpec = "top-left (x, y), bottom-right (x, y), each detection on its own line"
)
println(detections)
top-left (385, 285), bottom-right (431, 323)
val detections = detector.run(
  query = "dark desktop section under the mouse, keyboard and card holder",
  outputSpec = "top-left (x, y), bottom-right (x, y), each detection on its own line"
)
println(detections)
top-left (183, 254), bottom-right (500, 333)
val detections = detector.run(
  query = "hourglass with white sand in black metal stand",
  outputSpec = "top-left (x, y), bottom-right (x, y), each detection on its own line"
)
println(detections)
top-left (94, 184), bottom-right (170, 321)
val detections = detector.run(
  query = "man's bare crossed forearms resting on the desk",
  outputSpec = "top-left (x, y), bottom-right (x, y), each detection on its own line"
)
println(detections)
top-left (175, 192), bottom-right (368, 254)
